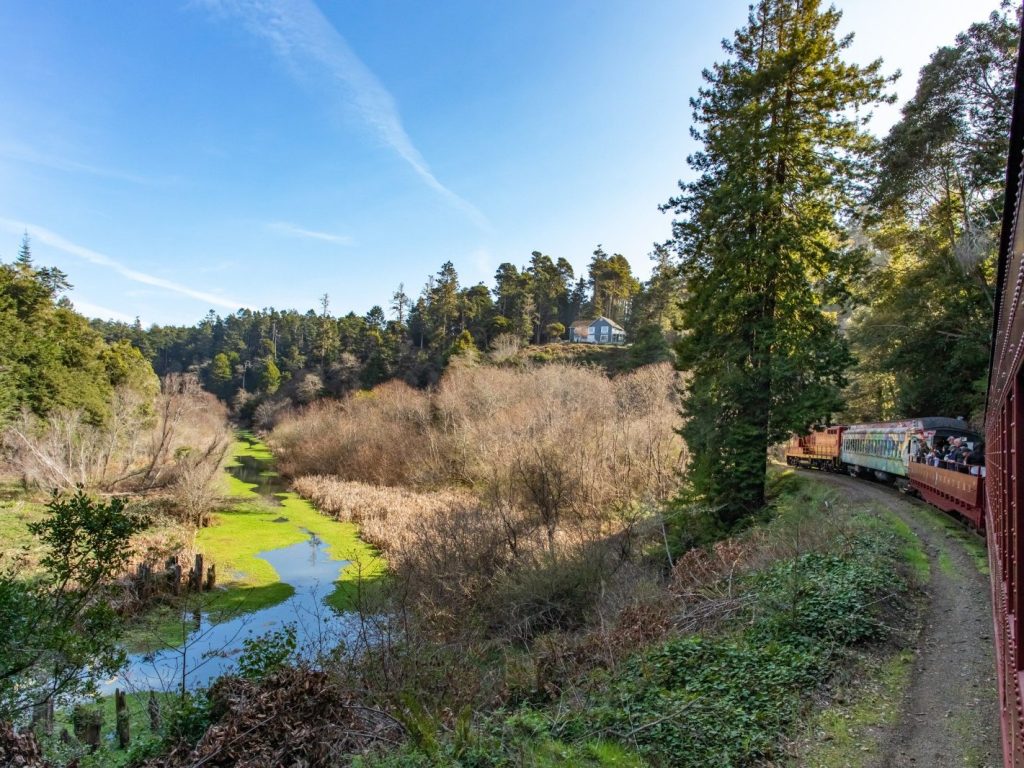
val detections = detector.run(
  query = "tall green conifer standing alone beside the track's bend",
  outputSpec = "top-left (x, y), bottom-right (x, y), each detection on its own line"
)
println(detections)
top-left (663, 0), bottom-right (886, 527)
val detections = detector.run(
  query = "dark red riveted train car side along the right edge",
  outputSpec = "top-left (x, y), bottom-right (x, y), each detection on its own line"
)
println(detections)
top-left (985, 6), bottom-right (1024, 768)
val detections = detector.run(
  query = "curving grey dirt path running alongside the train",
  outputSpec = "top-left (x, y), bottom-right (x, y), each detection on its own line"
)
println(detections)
top-left (809, 472), bottom-right (1002, 768)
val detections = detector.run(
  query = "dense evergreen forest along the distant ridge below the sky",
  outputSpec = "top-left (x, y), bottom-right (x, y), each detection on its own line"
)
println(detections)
top-left (81, 247), bottom-right (679, 415)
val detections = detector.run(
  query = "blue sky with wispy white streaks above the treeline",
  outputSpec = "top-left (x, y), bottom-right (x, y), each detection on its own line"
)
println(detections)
top-left (0, 0), bottom-right (995, 325)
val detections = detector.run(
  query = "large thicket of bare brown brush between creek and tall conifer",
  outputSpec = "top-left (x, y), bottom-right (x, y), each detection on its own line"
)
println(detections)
top-left (271, 365), bottom-right (683, 640)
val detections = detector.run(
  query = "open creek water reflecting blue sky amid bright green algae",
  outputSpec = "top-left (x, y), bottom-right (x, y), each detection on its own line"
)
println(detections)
top-left (103, 438), bottom-right (360, 692)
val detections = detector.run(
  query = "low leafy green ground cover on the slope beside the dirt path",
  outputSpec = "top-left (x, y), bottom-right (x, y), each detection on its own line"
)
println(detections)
top-left (570, 535), bottom-right (894, 768)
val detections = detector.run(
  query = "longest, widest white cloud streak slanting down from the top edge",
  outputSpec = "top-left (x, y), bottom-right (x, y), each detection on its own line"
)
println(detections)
top-left (204, 0), bottom-right (489, 229)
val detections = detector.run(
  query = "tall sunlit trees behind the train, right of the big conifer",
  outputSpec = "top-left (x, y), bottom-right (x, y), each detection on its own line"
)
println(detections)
top-left (845, 5), bottom-right (1020, 421)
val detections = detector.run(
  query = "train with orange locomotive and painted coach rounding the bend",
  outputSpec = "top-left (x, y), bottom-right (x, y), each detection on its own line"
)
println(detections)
top-left (784, 417), bottom-right (987, 531)
